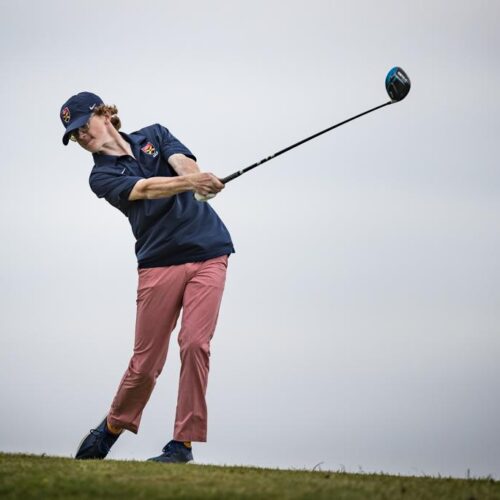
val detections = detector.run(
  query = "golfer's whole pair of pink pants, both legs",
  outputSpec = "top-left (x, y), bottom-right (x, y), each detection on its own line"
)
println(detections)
top-left (108, 255), bottom-right (228, 441)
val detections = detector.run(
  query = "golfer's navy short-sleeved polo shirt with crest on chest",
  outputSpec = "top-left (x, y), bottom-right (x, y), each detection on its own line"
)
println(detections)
top-left (89, 124), bottom-right (234, 268)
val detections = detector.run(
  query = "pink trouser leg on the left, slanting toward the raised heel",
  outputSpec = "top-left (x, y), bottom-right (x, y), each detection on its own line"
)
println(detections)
top-left (108, 266), bottom-right (186, 434)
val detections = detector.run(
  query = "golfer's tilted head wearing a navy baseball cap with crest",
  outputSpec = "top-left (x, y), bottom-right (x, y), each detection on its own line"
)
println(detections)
top-left (60, 92), bottom-right (121, 153)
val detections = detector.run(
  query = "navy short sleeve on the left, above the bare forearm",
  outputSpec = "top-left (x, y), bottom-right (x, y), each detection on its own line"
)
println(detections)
top-left (89, 171), bottom-right (142, 215)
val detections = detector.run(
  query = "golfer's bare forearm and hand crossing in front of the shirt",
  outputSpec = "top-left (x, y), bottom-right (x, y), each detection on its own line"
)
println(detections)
top-left (128, 172), bottom-right (224, 201)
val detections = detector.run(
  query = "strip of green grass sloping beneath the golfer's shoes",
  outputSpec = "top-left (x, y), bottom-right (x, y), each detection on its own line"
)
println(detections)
top-left (0, 453), bottom-right (500, 500)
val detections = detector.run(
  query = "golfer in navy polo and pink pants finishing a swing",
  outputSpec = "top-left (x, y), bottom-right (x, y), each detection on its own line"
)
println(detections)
top-left (60, 92), bottom-right (234, 463)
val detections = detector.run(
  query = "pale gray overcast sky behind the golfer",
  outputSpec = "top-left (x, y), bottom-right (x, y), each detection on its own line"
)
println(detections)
top-left (0, 0), bottom-right (500, 478)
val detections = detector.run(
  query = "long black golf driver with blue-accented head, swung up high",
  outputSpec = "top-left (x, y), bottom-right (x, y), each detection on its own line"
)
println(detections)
top-left (195, 66), bottom-right (411, 201)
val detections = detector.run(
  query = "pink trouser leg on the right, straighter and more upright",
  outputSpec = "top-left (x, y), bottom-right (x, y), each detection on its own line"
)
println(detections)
top-left (174, 256), bottom-right (227, 442)
